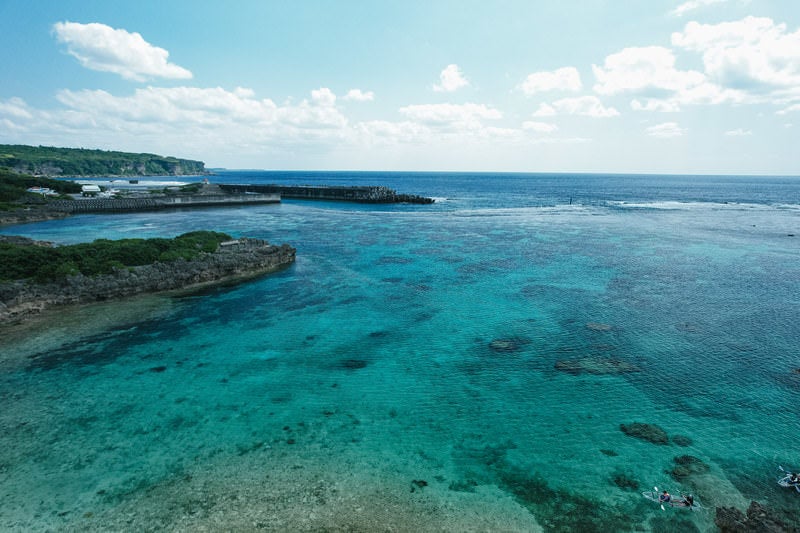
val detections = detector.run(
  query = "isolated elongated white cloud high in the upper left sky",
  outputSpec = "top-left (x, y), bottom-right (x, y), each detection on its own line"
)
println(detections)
top-left (53, 22), bottom-right (192, 81)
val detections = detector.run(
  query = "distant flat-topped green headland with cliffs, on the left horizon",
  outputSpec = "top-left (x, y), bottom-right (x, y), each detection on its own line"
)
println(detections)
top-left (0, 144), bottom-right (206, 176)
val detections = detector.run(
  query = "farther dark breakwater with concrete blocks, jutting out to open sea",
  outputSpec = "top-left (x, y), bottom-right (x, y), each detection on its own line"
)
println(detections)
top-left (219, 184), bottom-right (434, 204)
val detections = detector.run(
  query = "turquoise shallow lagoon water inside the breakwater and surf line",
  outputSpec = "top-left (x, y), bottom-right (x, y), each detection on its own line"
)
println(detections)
top-left (0, 172), bottom-right (800, 531)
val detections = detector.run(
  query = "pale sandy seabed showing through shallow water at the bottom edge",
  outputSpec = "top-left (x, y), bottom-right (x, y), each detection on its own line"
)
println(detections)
top-left (73, 446), bottom-right (542, 532)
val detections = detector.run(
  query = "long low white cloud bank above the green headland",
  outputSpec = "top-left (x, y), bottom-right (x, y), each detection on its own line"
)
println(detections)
top-left (0, 87), bottom-right (348, 151)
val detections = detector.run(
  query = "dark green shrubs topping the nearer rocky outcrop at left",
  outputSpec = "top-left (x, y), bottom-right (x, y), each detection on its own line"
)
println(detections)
top-left (0, 231), bottom-right (232, 283)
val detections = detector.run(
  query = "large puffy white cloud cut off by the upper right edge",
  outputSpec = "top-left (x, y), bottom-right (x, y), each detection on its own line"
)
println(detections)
top-left (672, 17), bottom-right (800, 94)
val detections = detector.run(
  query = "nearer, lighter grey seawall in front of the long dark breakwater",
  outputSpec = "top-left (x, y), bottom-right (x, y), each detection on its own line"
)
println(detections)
top-left (48, 194), bottom-right (281, 214)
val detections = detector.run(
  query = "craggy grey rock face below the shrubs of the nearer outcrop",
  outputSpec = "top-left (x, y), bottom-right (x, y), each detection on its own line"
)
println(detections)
top-left (0, 239), bottom-right (296, 323)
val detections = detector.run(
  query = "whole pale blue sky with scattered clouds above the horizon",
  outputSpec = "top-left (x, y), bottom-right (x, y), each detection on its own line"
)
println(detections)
top-left (0, 0), bottom-right (800, 175)
